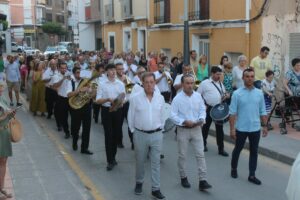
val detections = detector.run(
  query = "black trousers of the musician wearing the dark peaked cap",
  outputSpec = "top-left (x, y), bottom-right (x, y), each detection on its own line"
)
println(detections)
top-left (101, 106), bottom-right (123, 163)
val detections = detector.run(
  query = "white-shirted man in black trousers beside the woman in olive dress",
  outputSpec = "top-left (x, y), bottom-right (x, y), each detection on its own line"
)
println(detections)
top-left (42, 59), bottom-right (60, 120)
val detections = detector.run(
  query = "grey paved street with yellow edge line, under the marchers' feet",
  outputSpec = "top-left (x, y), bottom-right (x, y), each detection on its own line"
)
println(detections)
top-left (9, 97), bottom-right (290, 200)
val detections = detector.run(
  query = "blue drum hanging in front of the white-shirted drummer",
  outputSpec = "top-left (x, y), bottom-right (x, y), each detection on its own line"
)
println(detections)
top-left (210, 102), bottom-right (229, 125)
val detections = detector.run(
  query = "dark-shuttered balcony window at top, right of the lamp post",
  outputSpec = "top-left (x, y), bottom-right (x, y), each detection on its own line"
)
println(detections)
top-left (189, 0), bottom-right (209, 21)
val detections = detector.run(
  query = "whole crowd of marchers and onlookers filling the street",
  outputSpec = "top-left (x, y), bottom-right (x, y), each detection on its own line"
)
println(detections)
top-left (0, 47), bottom-right (300, 199)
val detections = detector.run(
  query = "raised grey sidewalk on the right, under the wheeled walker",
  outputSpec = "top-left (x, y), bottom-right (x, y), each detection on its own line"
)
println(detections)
top-left (208, 118), bottom-right (300, 165)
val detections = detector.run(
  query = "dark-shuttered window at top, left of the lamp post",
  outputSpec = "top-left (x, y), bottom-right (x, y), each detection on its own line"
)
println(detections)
top-left (154, 0), bottom-right (170, 24)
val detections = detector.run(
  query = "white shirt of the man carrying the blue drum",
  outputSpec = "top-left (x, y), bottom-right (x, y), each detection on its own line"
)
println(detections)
top-left (197, 78), bottom-right (226, 106)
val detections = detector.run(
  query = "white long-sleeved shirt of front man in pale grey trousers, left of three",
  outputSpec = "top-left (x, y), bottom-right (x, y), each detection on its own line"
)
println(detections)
top-left (127, 91), bottom-right (165, 132)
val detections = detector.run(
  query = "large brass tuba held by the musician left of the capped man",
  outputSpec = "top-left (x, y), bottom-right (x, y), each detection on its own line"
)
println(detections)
top-left (69, 73), bottom-right (100, 110)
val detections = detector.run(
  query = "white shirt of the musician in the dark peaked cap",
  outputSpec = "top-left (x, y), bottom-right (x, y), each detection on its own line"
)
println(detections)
top-left (96, 79), bottom-right (126, 107)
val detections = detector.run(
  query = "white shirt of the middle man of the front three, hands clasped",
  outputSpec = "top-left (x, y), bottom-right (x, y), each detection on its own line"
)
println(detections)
top-left (171, 91), bottom-right (206, 126)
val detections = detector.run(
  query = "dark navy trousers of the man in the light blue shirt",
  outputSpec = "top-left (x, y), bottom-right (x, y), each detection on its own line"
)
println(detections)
top-left (231, 130), bottom-right (260, 176)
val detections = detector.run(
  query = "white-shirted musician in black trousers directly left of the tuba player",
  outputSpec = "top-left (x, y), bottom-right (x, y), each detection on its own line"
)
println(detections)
top-left (53, 63), bottom-right (71, 139)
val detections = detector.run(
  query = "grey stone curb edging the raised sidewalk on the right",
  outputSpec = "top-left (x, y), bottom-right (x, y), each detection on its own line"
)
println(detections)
top-left (209, 130), bottom-right (295, 166)
